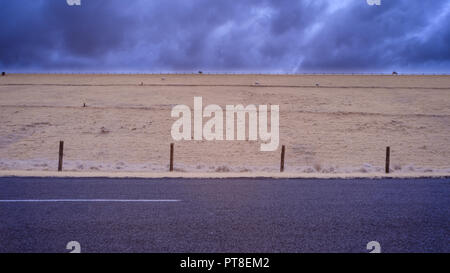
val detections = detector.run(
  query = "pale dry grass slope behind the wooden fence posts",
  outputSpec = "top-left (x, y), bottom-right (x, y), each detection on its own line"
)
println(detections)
top-left (0, 74), bottom-right (450, 173)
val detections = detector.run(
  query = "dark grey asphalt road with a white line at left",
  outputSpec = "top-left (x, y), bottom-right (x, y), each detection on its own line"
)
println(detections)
top-left (0, 178), bottom-right (450, 253)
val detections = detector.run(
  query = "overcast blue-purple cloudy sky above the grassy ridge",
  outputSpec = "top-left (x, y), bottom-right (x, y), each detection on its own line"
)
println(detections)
top-left (0, 0), bottom-right (450, 73)
